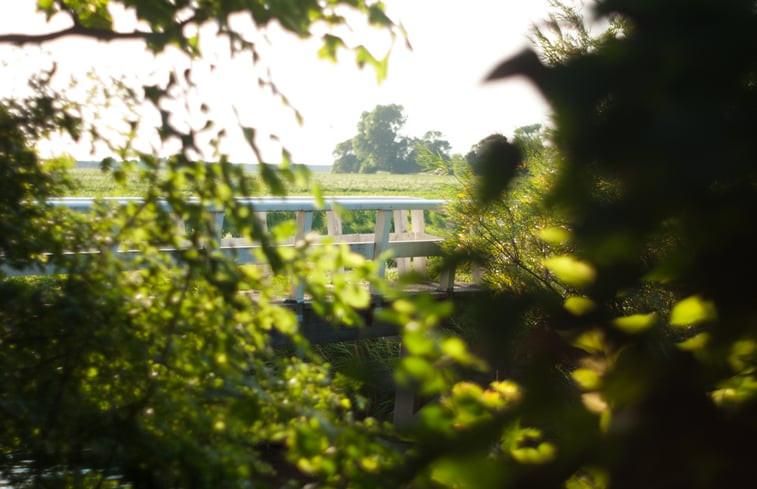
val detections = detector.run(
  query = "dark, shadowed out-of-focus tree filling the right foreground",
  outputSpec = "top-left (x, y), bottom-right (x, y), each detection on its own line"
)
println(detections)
top-left (386, 0), bottom-right (757, 488)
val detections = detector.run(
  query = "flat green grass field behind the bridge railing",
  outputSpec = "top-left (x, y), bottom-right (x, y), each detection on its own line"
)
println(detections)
top-left (70, 169), bottom-right (459, 199)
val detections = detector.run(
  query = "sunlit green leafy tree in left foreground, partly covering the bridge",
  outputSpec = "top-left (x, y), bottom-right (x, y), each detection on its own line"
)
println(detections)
top-left (0, 0), bottom-right (410, 488)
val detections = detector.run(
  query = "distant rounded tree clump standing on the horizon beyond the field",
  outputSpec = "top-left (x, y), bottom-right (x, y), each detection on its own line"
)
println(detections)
top-left (332, 104), bottom-right (450, 173)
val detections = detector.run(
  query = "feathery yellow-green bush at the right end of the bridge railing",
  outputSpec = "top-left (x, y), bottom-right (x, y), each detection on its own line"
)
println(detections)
top-left (446, 131), bottom-right (568, 298)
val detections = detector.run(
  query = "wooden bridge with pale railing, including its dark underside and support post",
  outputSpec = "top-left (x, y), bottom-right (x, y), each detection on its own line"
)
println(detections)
top-left (0, 196), bottom-right (478, 422)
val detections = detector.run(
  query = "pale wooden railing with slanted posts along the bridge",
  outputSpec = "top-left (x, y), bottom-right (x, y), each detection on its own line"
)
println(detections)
top-left (3, 196), bottom-right (454, 302)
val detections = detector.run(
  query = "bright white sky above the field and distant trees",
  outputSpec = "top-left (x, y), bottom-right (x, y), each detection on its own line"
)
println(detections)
top-left (0, 0), bottom-right (548, 164)
